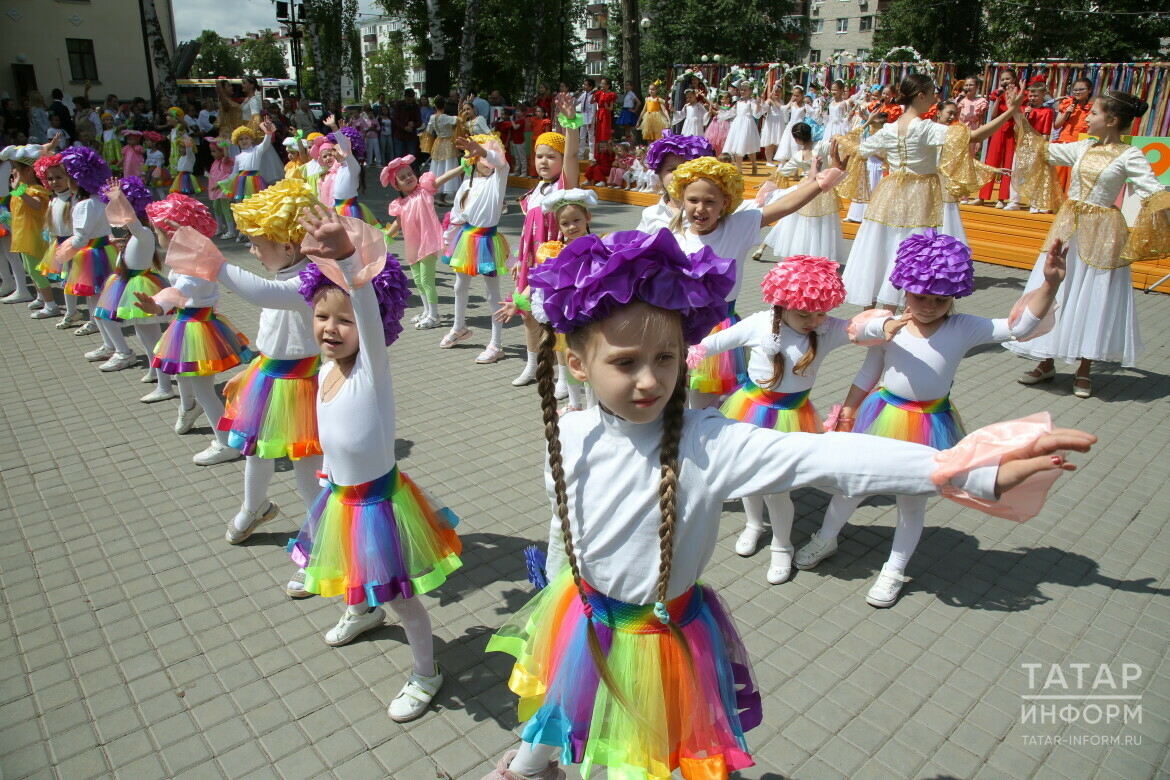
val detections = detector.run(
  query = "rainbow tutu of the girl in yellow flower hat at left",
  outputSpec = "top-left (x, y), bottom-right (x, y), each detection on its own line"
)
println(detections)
top-left (218, 354), bottom-right (321, 461)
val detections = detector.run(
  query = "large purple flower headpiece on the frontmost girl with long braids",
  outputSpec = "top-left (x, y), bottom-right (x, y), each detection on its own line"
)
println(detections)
top-left (528, 228), bottom-right (735, 345)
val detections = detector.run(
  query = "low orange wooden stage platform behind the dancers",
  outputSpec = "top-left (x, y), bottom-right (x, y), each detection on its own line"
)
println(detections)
top-left (508, 174), bottom-right (1170, 292)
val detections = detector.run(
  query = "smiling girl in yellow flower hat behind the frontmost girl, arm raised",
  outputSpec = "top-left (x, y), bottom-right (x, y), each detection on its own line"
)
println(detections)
top-left (670, 151), bottom-right (844, 408)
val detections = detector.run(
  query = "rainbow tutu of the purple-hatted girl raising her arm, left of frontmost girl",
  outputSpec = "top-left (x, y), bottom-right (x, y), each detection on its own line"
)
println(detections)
top-left (289, 465), bottom-right (462, 607)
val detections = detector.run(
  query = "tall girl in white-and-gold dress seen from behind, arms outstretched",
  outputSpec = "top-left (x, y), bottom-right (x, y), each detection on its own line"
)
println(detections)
top-left (844, 74), bottom-right (1024, 306)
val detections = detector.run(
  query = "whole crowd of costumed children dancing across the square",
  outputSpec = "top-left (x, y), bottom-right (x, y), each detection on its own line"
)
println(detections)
top-left (9, 76), bottom-right (1170, 780)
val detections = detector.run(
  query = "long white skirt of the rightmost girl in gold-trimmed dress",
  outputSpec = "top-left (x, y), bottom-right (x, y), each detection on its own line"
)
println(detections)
top-left (1004, 235), bottom-right (1142, 368)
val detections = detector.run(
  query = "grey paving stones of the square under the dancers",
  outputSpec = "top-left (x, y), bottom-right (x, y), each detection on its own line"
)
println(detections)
top-left (0, 184), bottom-right (1170, 780)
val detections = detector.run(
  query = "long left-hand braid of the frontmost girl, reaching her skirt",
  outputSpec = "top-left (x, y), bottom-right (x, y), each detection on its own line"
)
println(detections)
top-left (536, 324), bottom-right (649, 727)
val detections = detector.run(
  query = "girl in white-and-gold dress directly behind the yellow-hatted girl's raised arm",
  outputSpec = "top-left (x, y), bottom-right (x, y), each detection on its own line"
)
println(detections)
top-left (757, 122), bottom-right (845, 262)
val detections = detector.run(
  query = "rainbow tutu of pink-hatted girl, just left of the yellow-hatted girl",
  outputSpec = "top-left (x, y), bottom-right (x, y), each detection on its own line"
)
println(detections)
top-left (151, 306), bottom-right (253, 377)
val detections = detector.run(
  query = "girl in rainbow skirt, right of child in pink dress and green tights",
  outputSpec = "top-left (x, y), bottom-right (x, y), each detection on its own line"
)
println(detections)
top-left (439, 134), bottom-right (512, 365)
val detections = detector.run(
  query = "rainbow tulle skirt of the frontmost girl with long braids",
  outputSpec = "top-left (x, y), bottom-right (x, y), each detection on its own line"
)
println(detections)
top-left (488, 567), bottom-right (762, 780)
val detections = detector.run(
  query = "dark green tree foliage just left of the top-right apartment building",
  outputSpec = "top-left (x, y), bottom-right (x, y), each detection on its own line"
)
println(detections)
top-left (636, 0), bottom-right (809, 88)
